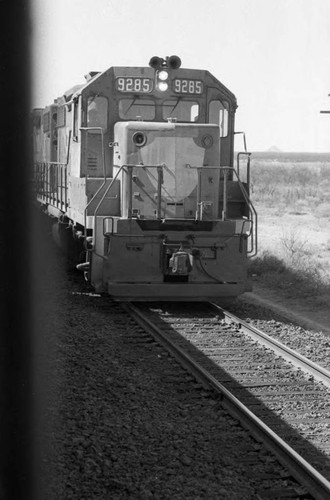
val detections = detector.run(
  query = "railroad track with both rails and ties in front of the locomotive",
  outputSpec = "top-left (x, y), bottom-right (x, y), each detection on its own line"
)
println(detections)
top-left (125, 304), bottom-right (330, 499)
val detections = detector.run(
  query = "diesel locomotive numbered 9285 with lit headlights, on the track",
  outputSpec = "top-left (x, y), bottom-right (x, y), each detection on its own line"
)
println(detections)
top-left (32, 56), bottom-right (257, 302)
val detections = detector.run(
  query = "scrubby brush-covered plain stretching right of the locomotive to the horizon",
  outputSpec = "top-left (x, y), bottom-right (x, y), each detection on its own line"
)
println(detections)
top-left (249, 157), bottom-right (330, 307)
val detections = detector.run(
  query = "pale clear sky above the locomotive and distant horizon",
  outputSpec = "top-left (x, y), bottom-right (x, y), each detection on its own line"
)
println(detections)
top-left (31, 0), bottom-right (330, 152)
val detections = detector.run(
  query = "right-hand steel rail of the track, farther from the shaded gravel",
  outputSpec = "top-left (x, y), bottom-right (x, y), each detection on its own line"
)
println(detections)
top-left (211, 303), bottom-right (330, 387)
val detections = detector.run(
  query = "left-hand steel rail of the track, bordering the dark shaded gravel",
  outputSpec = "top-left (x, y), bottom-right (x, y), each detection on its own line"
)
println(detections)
top-left (122, 304), bottom-right (330, 500)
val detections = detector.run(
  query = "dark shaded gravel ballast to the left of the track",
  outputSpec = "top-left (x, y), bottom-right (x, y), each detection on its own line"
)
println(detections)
top-left (33, 213), bottom-right (306, 500)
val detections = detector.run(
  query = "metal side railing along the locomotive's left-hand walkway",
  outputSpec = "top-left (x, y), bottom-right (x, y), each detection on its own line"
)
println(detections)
top-left (34, 162), bottom-right (68, 211)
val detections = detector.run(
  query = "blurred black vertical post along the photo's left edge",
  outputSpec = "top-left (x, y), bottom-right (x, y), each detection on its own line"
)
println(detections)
top-left (0, 0), bottom-right (35, 500)
